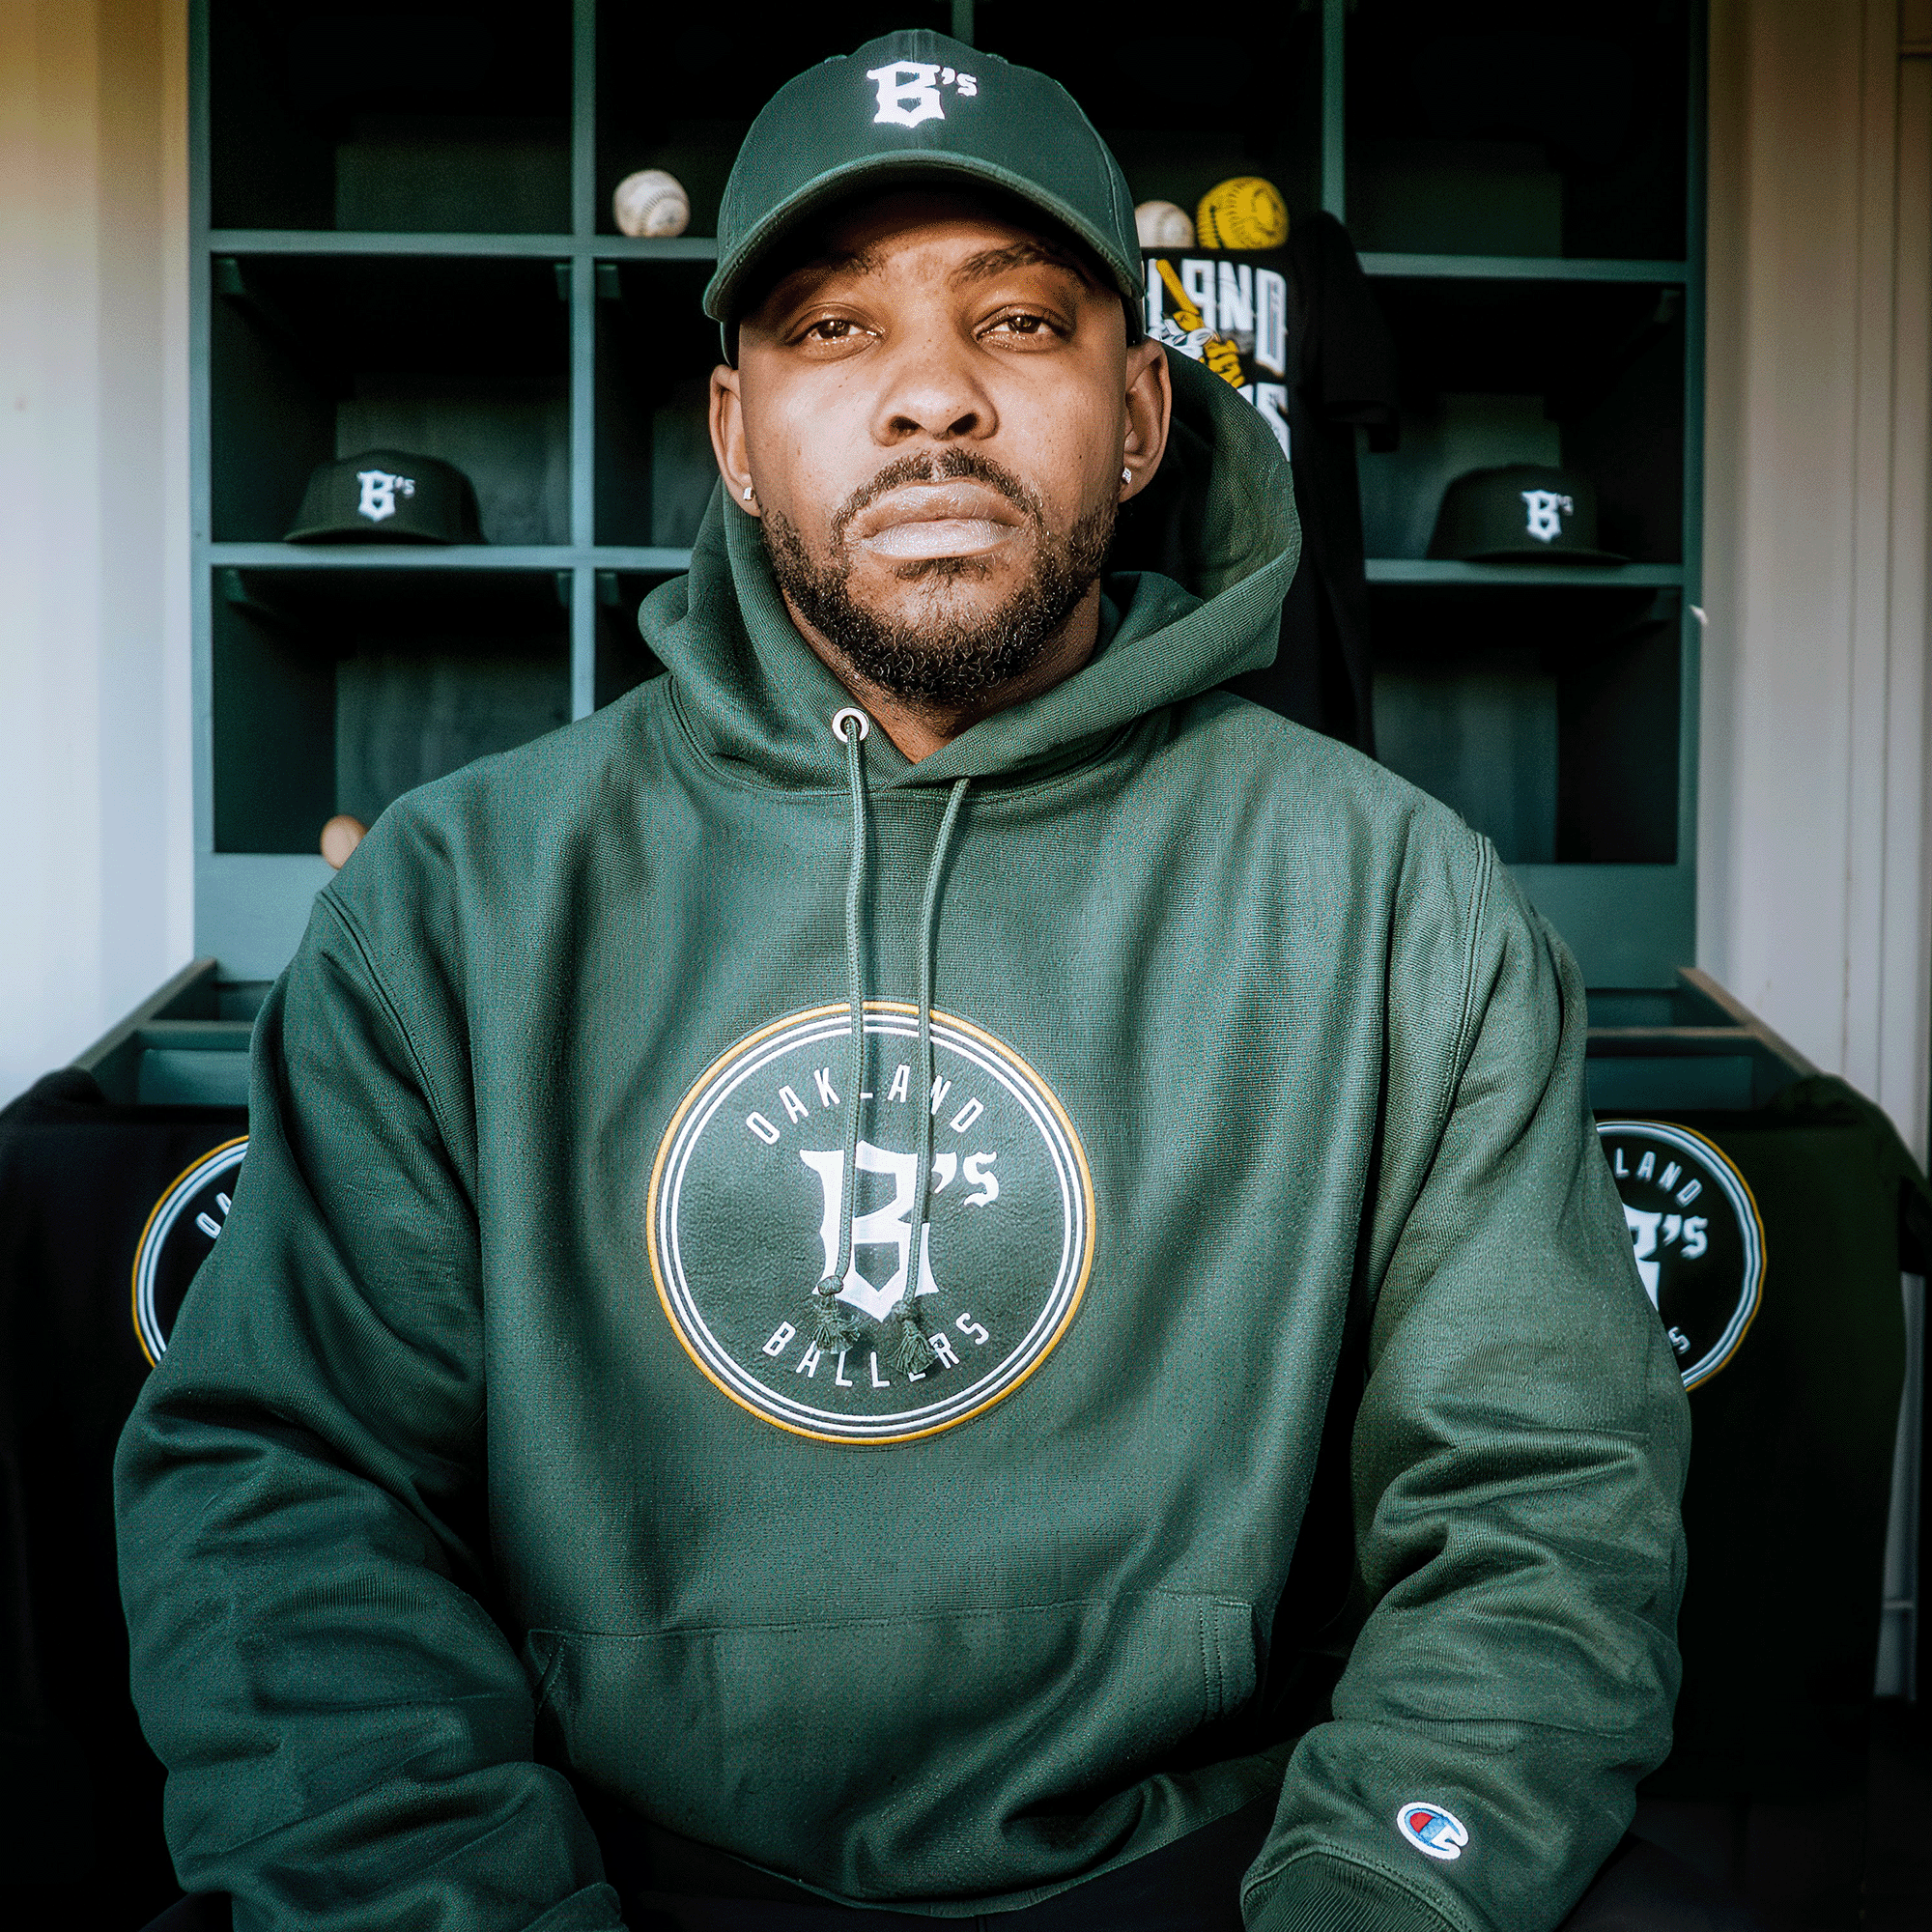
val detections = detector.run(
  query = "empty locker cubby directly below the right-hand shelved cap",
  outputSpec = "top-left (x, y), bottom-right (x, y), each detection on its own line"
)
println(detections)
top-left (1374, 585), bottom-right (1681, 866)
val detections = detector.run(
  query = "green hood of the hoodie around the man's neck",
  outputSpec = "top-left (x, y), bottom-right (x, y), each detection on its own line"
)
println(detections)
top-left (638, 354), bottom-right (1300, 790)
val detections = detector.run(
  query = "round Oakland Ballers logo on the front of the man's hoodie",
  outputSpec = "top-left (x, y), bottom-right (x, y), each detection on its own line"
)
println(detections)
top-left (647, 1001), bottom-right (1094, 1443)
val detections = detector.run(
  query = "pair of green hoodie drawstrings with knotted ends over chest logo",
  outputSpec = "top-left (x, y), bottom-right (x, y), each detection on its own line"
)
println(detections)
top-left (811, 705), bottom-right (970, 1376)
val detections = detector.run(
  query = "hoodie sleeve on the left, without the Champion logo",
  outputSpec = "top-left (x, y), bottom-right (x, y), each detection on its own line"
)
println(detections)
top-left (116, 893), bottom-right (620, 1932)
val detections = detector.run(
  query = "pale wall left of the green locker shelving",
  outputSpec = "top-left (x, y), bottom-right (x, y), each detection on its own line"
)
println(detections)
top-left (0, 0), bottom-right (193, 1101)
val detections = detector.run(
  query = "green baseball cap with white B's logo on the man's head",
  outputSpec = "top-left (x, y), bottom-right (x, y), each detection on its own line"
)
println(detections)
top-left (705, 27), bottom-right (1142, 340)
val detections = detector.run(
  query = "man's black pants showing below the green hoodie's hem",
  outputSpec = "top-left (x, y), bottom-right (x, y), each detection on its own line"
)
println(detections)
top-left (136, 1804), bottom-right (1760, 1932)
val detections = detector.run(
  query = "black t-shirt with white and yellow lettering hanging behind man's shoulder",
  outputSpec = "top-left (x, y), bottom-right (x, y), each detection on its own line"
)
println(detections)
top-left (1146, 214), bottom-right (1397, 752)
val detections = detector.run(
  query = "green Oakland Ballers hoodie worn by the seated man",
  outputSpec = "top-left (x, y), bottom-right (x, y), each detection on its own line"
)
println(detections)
top-left (118, 361), bottom-right (1687, 1932)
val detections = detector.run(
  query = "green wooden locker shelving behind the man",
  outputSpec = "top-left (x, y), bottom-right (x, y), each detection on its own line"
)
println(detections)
top-left (191, 0), bottom-right (1704, 1036)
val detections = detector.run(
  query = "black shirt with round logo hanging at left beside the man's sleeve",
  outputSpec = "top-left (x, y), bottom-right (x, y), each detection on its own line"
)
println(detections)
top-left (0, 1068), bottom-right (247, 1926)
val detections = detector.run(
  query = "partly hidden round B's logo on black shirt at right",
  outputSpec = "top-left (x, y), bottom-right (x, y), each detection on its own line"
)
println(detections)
top-left (1596, 1121), bottom-right (1764, 1389)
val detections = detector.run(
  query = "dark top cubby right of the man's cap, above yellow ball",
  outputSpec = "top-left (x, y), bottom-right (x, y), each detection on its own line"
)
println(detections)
top-left (980, 0), bottom-right (1321, 228)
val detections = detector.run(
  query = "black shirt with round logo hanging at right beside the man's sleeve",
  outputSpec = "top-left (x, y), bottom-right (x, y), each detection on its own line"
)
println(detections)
top-left (1598, 1074), bottom-right (1932, 1799)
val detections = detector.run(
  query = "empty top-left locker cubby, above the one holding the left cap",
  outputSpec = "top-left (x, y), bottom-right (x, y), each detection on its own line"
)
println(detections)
top-left (209, 0), bottom-right (570, 234)
